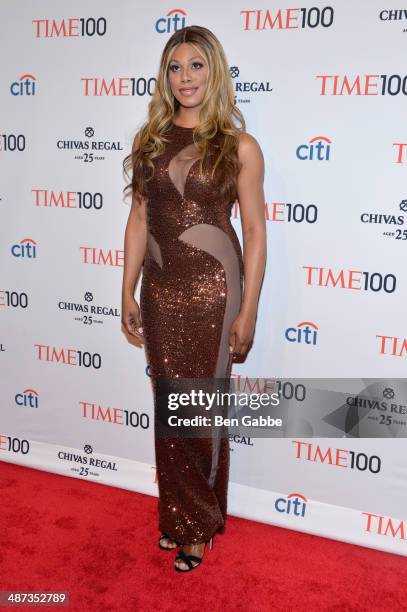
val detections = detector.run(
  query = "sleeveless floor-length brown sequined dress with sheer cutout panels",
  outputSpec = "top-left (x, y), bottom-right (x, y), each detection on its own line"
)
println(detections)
top-left (140, 123), bottom-right (243, 544)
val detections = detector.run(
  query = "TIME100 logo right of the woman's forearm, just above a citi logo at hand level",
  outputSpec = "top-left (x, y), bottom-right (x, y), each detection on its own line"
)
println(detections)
top-left (302, 266), bottom-right (396, 293)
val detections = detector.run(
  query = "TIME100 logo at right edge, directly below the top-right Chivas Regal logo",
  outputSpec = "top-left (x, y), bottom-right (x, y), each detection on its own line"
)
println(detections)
top-left (315, 74), bottom-right (407, 97)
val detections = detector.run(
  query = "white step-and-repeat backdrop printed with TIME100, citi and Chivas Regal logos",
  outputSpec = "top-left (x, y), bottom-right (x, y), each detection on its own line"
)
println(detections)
top-left (0, 0), bottom-right (407, 555)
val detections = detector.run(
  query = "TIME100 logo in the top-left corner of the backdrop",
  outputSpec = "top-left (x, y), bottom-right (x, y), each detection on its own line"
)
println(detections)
top-left (32, 17), bottom-right (106, 38)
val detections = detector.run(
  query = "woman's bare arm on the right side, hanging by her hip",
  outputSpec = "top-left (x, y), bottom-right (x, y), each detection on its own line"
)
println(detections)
top-left (229, 133), bottom-right (267, 355)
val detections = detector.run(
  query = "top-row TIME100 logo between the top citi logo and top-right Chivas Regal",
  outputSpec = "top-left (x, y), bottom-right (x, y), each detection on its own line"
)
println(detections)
top-left (240, 6), bottom-right (334, 30)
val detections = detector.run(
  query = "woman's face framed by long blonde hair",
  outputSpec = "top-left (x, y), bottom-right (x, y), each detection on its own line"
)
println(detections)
top-left (168, 43), bottom-right (208, 108)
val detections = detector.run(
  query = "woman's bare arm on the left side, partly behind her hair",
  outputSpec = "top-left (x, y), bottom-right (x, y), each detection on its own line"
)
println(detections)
top-left (122, 133), bottom-right (147, 342)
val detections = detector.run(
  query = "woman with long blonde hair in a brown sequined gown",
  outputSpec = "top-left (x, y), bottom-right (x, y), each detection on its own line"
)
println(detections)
top-left (122, 26), bottom-right (266, 571)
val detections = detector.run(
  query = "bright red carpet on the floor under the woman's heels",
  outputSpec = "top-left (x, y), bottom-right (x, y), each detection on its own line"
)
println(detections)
top-left (0, 462), bottom-right (407, 612)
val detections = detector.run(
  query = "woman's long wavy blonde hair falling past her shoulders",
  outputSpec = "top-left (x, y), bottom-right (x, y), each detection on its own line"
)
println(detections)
top-left (123, 25), bottom-right (246, 202)
